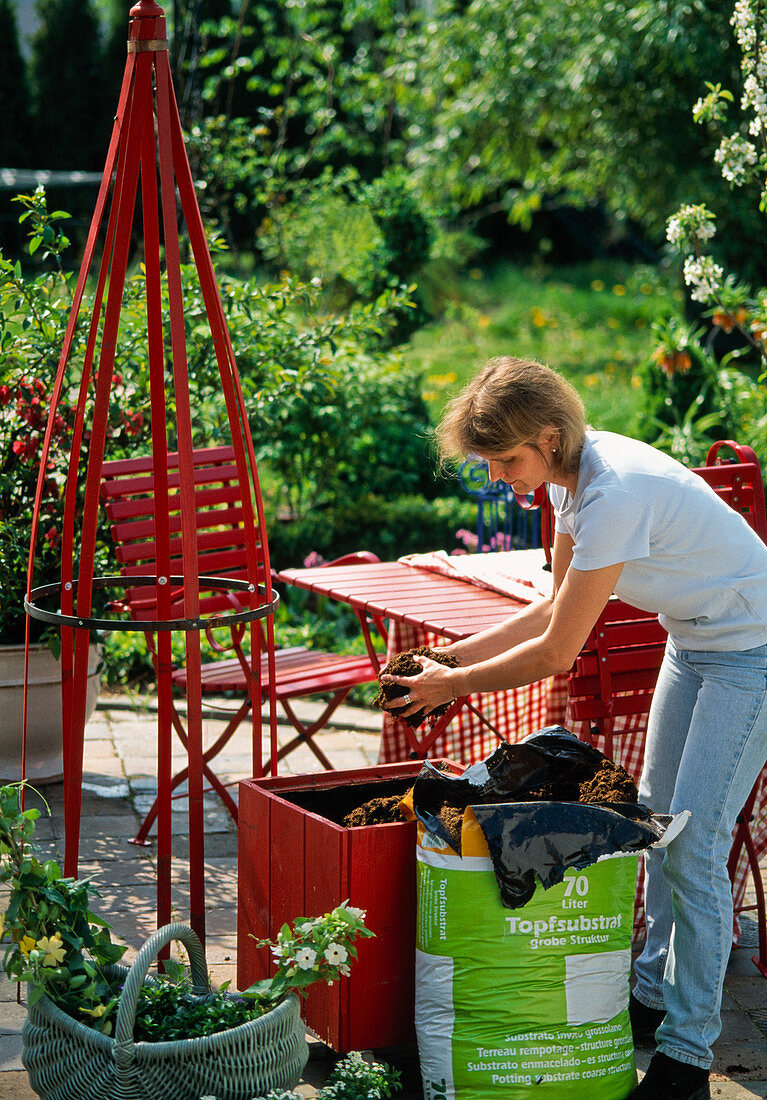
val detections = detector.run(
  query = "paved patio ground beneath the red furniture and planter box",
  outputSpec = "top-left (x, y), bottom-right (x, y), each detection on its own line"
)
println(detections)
top-left (0, 696), bottom-right (767, 1100)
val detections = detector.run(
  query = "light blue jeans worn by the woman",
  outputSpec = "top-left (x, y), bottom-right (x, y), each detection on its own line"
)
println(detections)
top-left (635, 640), bottom-right (767, 1069)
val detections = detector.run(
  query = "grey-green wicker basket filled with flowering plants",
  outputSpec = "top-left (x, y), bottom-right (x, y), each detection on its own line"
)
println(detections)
top-left (0, 784), bottom-right (373, 1100)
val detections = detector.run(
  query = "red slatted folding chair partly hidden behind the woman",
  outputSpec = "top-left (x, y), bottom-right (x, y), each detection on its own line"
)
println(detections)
top-left (568, 440), bottom-right (767, 977)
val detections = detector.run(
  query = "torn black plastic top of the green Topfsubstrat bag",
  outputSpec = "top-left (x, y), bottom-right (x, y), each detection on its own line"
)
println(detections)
top-left (413, 726), bottom-right (668, 909)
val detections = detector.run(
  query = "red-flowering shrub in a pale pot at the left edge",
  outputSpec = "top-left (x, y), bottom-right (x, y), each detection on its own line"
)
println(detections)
top-left (0, 188), bottom-right (152, 782)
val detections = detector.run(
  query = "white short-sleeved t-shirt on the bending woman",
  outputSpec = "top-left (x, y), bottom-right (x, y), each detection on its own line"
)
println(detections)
top-left (549, 431), bottom-right (767, 652)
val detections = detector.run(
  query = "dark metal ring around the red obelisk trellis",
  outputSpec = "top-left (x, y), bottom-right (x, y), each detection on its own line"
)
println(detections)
top-left (24, 574), bottom-right (280, 630)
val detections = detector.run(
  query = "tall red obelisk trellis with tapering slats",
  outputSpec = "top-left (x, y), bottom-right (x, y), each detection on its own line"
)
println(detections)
top-left (23, 0), bottom-right (276, 936)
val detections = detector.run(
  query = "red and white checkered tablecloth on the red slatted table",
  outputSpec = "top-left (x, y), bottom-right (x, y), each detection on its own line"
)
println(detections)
top-left (379, 554), bottom-right (767, 942)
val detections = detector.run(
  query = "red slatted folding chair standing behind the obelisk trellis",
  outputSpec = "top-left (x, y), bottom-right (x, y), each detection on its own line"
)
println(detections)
top-left (101, 447), bottom-right (385, 843)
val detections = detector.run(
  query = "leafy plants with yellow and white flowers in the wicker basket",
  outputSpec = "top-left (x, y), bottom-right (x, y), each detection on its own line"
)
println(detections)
top-left (0, 783), bottom-right (374, 1042)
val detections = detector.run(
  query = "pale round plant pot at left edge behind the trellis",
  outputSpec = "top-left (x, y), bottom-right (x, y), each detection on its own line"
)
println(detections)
top-left (0, 645), bottom-right (100, 783)
